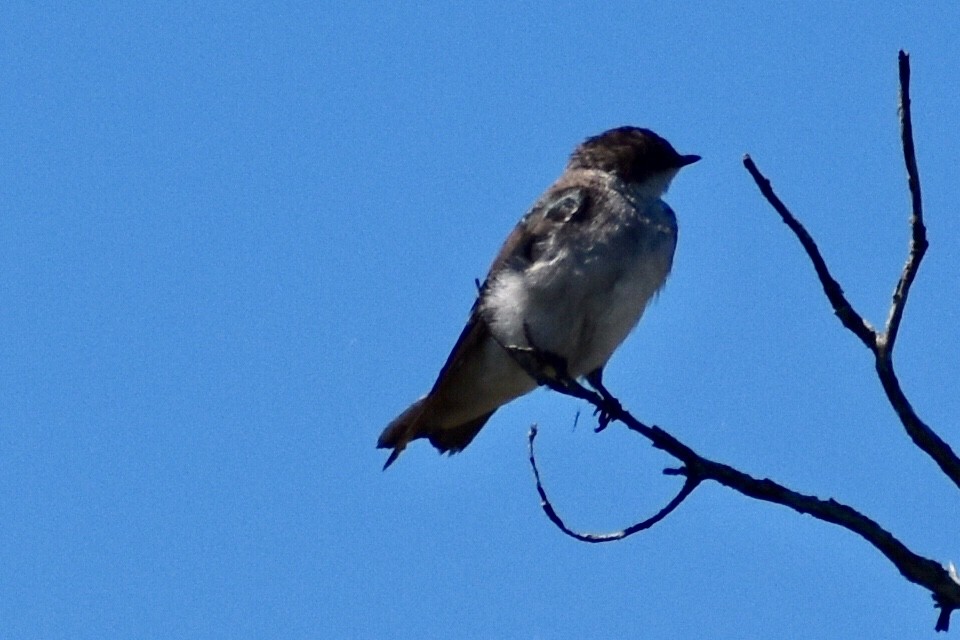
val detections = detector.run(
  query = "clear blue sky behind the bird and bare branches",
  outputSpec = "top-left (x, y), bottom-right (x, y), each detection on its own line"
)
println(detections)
top-left (0, 2), bottom-right (960, 639)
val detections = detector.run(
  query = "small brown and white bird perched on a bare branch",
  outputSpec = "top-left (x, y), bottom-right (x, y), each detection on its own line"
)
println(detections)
top-left (377, 127), bottom-right (700, 469)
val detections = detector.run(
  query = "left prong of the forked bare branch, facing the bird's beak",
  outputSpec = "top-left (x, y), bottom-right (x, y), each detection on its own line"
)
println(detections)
top-left (743, 156), bottom-right (877, 353)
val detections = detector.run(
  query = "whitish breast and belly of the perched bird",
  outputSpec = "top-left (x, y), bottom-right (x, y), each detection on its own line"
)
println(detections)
top-left (485, 182), bottom-right (676, 376)
